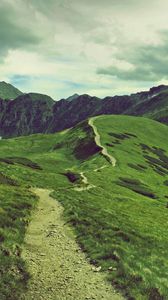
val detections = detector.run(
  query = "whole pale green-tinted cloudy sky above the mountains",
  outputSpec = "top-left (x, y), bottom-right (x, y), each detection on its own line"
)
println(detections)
top-left (0, 0), bottom-right (168, 100)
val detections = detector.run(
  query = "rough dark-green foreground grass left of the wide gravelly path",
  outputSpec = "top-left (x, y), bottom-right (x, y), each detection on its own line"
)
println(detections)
top-left (0, 183), bottom-right (37, 300)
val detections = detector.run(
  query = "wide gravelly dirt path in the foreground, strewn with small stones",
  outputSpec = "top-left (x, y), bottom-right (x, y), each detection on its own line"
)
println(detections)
top-left (21, 189), bottom-right (122, 300)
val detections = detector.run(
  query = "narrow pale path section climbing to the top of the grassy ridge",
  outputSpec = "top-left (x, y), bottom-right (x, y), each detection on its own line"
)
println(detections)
top-left (88, 117), bottom-right (116, 167)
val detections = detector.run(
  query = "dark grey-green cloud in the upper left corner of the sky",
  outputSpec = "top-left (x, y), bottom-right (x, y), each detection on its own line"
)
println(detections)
top-left (0, 3), bottom-right (40, 58)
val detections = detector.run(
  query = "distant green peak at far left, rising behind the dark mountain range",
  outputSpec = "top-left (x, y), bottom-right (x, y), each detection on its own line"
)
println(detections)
top-left (0, 81), bottom-right (22, 100)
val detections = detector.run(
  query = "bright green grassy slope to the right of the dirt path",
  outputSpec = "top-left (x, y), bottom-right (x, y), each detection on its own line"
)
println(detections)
top-left (52, 116), bottom-right (168, 299)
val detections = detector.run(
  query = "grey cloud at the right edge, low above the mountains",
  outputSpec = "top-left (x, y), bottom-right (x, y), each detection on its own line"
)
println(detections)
top-left (97, 32), bottom-right (168, 82)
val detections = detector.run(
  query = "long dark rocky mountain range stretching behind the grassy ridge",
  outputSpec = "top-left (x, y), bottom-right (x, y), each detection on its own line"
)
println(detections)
top-left (0, 85), bottom-right (168, 137)
